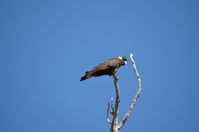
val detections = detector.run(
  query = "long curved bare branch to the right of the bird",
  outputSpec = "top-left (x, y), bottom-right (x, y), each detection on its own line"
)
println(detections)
top-left (118, 53), bottom-right (142, 129)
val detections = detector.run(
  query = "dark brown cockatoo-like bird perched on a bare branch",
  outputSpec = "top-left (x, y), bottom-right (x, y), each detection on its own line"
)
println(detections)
top-left (80, 56), bottom-right (127, 81)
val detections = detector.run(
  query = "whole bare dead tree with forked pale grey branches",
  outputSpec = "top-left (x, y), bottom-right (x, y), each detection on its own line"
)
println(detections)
top-left (107, 53), bottom-right (142, 132)
